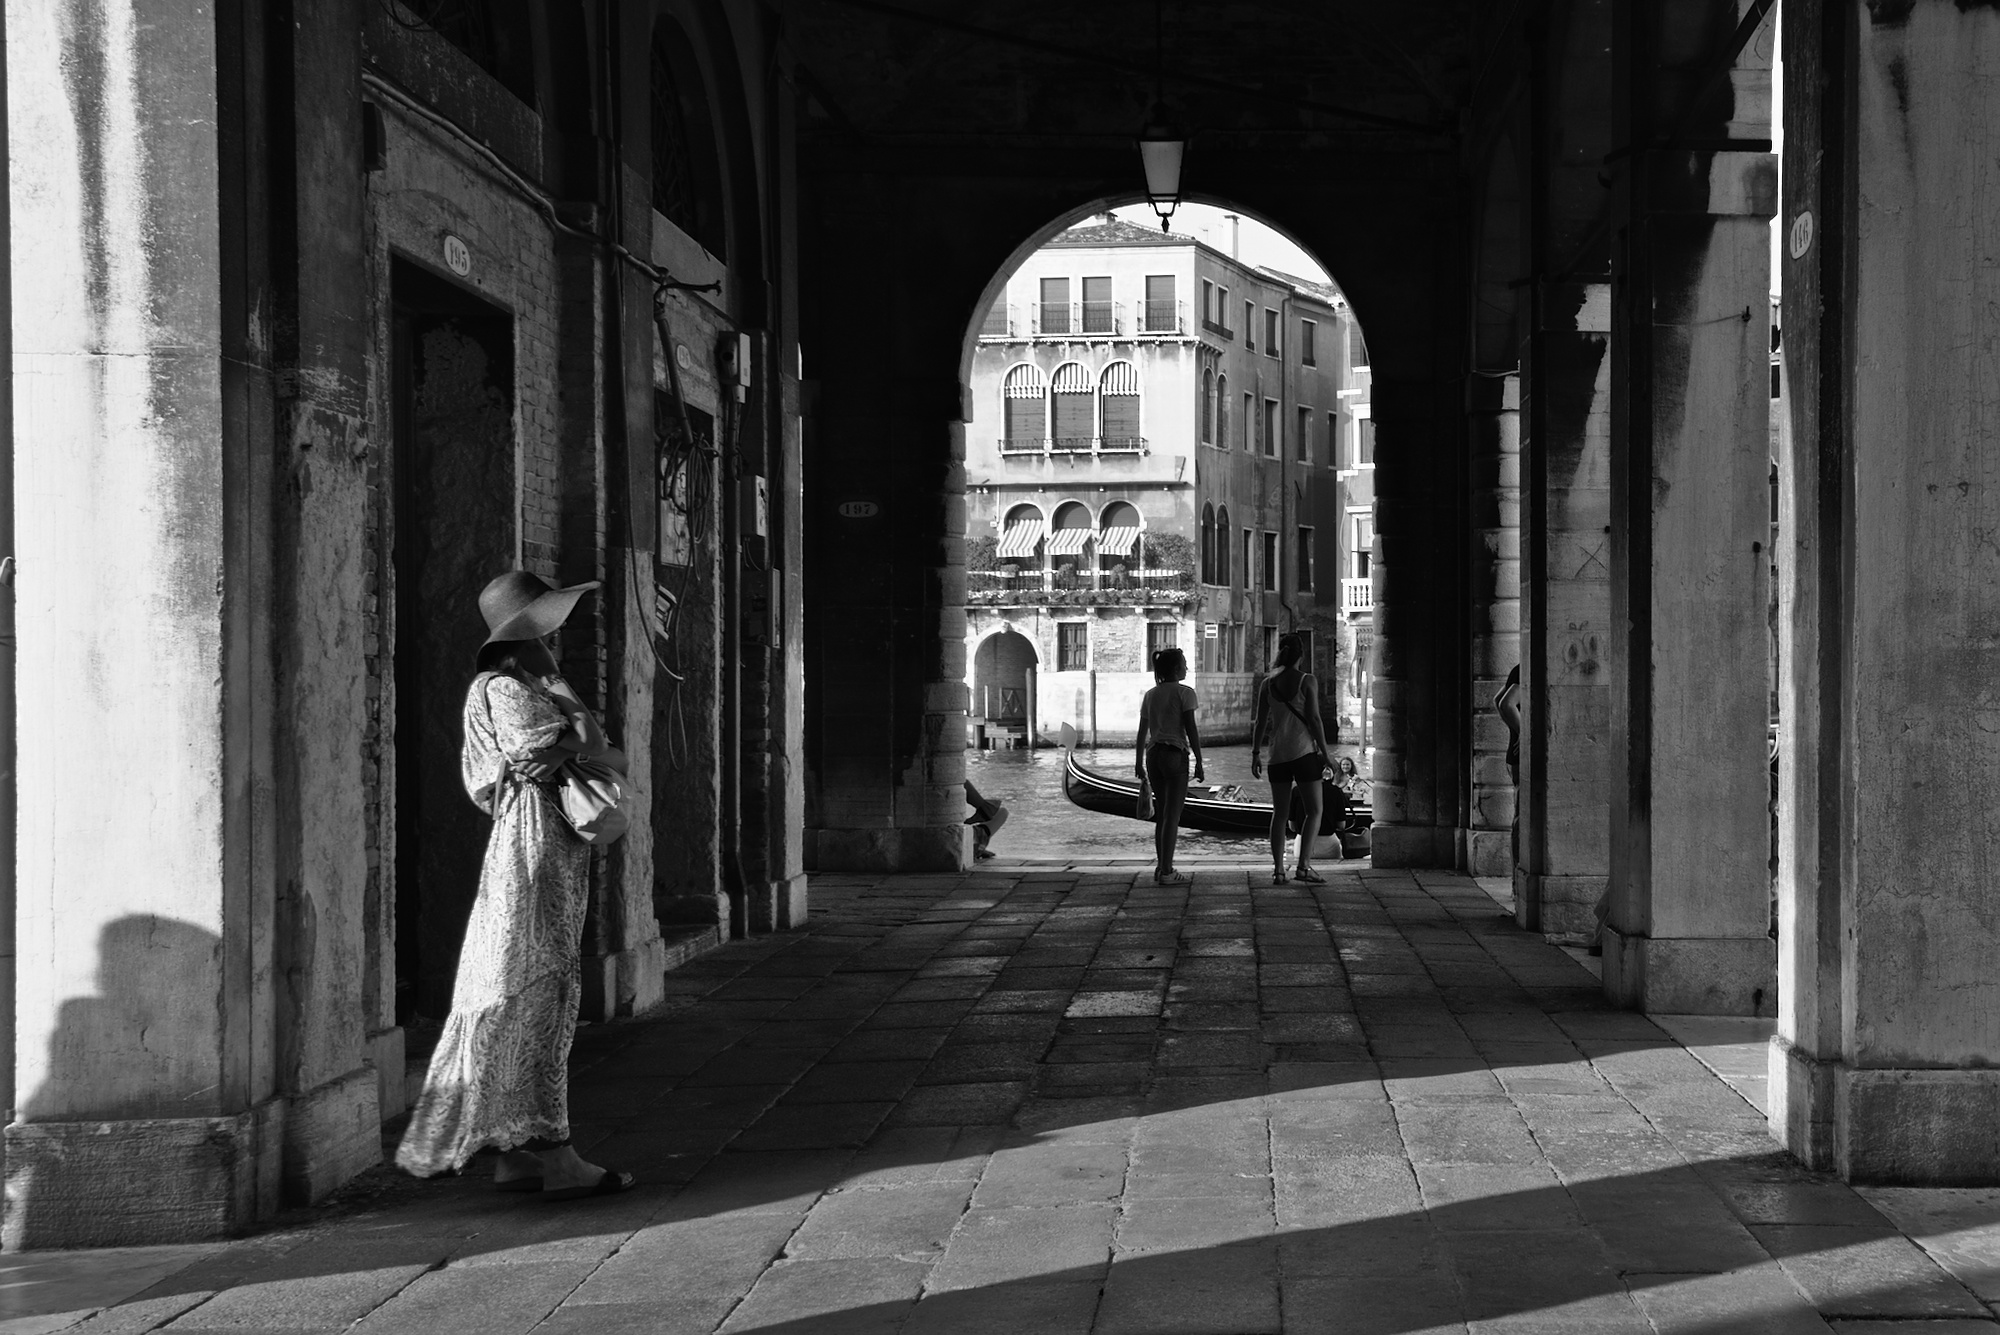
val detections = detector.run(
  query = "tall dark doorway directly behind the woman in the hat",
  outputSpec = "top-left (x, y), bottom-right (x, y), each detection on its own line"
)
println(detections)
top-left (390, 260), bottom-right (516, 1025)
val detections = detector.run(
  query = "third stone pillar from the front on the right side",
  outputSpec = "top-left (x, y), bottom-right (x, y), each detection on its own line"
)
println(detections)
top-left (1514, 284), bottom-right (1612, 943)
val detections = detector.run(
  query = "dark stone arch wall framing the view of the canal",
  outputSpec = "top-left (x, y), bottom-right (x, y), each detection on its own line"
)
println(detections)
top-left (800, 145), bottom-right (1466, 867)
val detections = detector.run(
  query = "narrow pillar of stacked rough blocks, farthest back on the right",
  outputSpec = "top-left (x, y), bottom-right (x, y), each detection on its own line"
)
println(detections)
top-left (1466, 374), bottom-right (1520, 875)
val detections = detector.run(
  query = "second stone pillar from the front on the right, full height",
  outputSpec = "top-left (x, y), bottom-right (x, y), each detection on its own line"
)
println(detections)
top-left (1604, 0), bottom-right (1778, 1015)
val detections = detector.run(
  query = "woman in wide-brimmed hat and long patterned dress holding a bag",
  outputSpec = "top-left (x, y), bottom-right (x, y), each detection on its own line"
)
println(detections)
top-left (396, 570), bottom-right (634, 1199)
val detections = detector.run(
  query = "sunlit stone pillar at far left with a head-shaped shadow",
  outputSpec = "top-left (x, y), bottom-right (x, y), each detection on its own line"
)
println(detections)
top-left (4, 0), bottom-right (286, 1249)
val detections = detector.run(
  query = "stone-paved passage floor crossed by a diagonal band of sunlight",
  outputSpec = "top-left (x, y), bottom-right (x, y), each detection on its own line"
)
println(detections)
top-left (11, 867), bottom-right (2000, 1335)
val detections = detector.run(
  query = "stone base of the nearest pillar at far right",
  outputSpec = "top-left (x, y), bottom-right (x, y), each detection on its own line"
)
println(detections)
top-left (1770, 1039), bottom-right (2000, 1187)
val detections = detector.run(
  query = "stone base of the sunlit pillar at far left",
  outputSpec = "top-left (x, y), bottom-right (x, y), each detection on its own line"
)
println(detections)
top-left (0, 1103), bottom-right (286, 1251)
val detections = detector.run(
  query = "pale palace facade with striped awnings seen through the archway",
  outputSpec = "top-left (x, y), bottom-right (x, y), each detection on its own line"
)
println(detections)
top-left (966, 218), bottom-right (1374, 745)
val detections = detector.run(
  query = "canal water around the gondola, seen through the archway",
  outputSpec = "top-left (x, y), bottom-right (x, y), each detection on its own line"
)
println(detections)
top-left (966, 745), bottom-right (1368, 867)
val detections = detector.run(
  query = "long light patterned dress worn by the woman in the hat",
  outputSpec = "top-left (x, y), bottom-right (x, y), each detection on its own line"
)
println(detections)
top-left (396, 671), bottom-right (590, 1177)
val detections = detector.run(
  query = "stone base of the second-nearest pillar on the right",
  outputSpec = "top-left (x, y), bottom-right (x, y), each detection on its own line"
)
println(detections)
top-left (1600, 927), bottom-right (1778, 1015)
